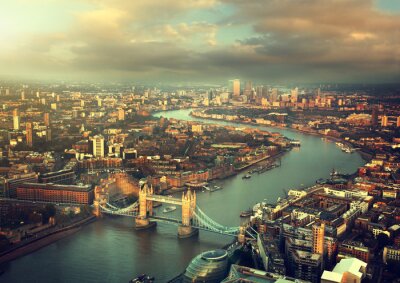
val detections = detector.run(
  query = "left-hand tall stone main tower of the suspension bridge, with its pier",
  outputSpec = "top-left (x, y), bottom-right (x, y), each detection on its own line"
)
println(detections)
top-left (135, 184), bottom-right (157, 230)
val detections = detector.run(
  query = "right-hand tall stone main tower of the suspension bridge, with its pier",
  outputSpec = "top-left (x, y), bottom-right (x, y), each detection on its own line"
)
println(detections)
top-left (178, 190), bottom-right (199, 238)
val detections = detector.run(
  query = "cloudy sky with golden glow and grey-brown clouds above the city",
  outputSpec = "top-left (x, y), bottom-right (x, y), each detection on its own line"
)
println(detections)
top-left (0, 0), bottom-right (400, 83)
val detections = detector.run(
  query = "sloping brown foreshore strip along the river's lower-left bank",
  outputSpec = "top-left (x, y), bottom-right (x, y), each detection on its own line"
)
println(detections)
top-left (0, 215), bottom-right (96, 264)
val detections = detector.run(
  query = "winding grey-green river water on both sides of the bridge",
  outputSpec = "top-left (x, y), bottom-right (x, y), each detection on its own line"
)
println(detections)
top-left (0, 110), bottom-right (363, 283)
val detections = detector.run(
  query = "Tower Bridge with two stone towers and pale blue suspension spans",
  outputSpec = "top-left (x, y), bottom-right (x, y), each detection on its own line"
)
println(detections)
top-left (95, 185), bottom-right (246, 238)
